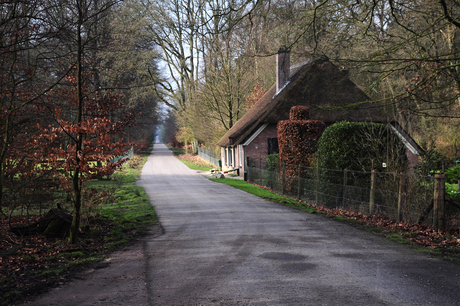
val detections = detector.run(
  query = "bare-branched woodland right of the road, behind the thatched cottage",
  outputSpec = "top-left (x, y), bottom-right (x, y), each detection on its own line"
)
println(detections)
top-left (156, 0), bottom-right (460, 161)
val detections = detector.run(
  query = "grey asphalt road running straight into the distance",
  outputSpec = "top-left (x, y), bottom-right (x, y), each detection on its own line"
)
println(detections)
top-left (23, 144), bottom-right (460, 306)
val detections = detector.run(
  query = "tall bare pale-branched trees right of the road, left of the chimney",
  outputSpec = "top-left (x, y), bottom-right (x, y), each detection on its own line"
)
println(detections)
top-left (143, 0), bottom-right (258, 147)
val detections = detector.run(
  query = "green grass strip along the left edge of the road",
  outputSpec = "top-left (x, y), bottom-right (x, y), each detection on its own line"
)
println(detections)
top-left (0, 145), bottom-right (158, 305)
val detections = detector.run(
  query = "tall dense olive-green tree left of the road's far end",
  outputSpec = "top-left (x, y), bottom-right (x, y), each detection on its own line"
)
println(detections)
top-left (98, 1), bottom-right (159, 140)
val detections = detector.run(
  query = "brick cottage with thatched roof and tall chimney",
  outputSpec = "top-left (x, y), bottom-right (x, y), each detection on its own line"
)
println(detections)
top-left (217, 46), bottom-right (422, 176)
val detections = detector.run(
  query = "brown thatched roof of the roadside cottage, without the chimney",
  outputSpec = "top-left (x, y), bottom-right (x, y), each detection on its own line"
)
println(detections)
top-left (217, 59), bottom-right (388, 147)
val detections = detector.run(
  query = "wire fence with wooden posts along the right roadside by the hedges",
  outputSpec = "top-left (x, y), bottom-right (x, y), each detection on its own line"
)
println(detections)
top-left (247, 160), bottom-right (460, 228)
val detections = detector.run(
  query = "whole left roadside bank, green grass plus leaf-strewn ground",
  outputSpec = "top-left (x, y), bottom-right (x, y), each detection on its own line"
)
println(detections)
top-left (0, 150), bottom-right (158, 305)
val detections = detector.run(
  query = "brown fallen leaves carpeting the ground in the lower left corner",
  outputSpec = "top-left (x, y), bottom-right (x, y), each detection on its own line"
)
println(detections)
top-left (0, 216), bottom-right (112, 305)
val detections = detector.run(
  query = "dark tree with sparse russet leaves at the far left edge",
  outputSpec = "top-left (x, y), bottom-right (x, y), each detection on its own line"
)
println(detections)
top-left (0, 0), bottom-right (67, 212)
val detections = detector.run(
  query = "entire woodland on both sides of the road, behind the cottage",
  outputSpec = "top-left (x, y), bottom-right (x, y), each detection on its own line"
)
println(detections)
top-left (0, 0), bottom-right (460, 245)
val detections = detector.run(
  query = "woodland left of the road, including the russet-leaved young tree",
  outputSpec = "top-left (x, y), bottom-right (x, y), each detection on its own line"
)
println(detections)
top-left (0, 0), bottom-right (159, 243)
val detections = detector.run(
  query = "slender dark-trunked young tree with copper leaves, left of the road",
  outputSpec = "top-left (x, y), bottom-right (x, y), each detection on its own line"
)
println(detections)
top-left (38, 0), bottom-right (123, 243)
